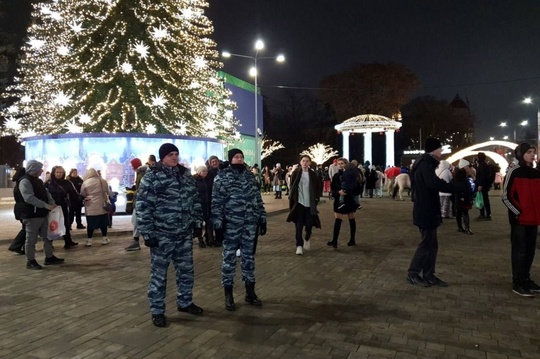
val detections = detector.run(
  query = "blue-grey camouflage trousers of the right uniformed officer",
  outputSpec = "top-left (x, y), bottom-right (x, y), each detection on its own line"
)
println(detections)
top-left (221, 223), bottom-right (257, 287)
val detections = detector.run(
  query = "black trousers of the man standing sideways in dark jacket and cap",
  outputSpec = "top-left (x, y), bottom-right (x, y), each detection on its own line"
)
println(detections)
top-left (409, 228), bottom-right (439, 278)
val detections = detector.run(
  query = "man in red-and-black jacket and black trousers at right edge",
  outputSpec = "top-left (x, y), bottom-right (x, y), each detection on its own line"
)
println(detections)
top-left (502, 143), bottom-right (540, 297)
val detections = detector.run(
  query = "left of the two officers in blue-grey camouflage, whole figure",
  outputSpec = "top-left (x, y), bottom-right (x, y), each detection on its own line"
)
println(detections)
top-left (136, 143), bottom-right (203, 327)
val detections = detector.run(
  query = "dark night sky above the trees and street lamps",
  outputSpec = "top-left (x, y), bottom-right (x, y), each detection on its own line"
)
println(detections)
top-left (2, 0), bottom-right (540, 140)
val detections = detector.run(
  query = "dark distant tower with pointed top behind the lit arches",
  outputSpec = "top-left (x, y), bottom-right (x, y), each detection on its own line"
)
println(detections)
top-left (450, 94), bottom-right (474, 150)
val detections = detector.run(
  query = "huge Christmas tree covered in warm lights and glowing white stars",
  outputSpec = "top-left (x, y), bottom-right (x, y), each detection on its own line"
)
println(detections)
top-left (2, 0), bottom-right (237, 139)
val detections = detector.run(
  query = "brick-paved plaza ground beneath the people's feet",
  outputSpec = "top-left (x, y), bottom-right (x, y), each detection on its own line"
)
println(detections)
top-left (0, 191), bottom-right (540, 359)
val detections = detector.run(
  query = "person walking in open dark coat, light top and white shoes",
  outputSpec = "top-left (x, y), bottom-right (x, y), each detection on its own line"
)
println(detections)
top-left (287, 155), bottom-right (321, 255)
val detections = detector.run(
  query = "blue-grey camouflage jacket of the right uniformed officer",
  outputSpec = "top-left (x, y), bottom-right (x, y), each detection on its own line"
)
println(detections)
top-left (210, 166), bottom-right (266, 228)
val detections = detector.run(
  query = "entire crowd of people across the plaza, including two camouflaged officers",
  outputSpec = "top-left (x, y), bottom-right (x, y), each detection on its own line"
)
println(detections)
top-left (10, 138), bottom-right (540, 327)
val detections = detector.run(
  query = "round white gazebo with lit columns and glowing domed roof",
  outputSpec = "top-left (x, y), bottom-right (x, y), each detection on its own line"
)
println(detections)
top-left (334, 114), bottom-right (401, 166)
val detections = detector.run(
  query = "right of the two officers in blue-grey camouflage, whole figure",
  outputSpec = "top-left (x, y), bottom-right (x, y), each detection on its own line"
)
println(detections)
top-left (211, 148), bottom-right (266, 311)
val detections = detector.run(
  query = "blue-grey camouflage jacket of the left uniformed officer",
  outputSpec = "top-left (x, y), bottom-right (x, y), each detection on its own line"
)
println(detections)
top-left (136, 162), bottom-right (202, 238)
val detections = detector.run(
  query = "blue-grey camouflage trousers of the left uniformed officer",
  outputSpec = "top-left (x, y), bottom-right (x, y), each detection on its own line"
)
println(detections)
top-left (148, 238), bottom-right (194, 314)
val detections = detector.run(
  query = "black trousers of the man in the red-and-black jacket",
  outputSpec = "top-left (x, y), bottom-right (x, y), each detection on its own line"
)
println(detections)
top-left (510, 224), bottom-right (538, 284)
